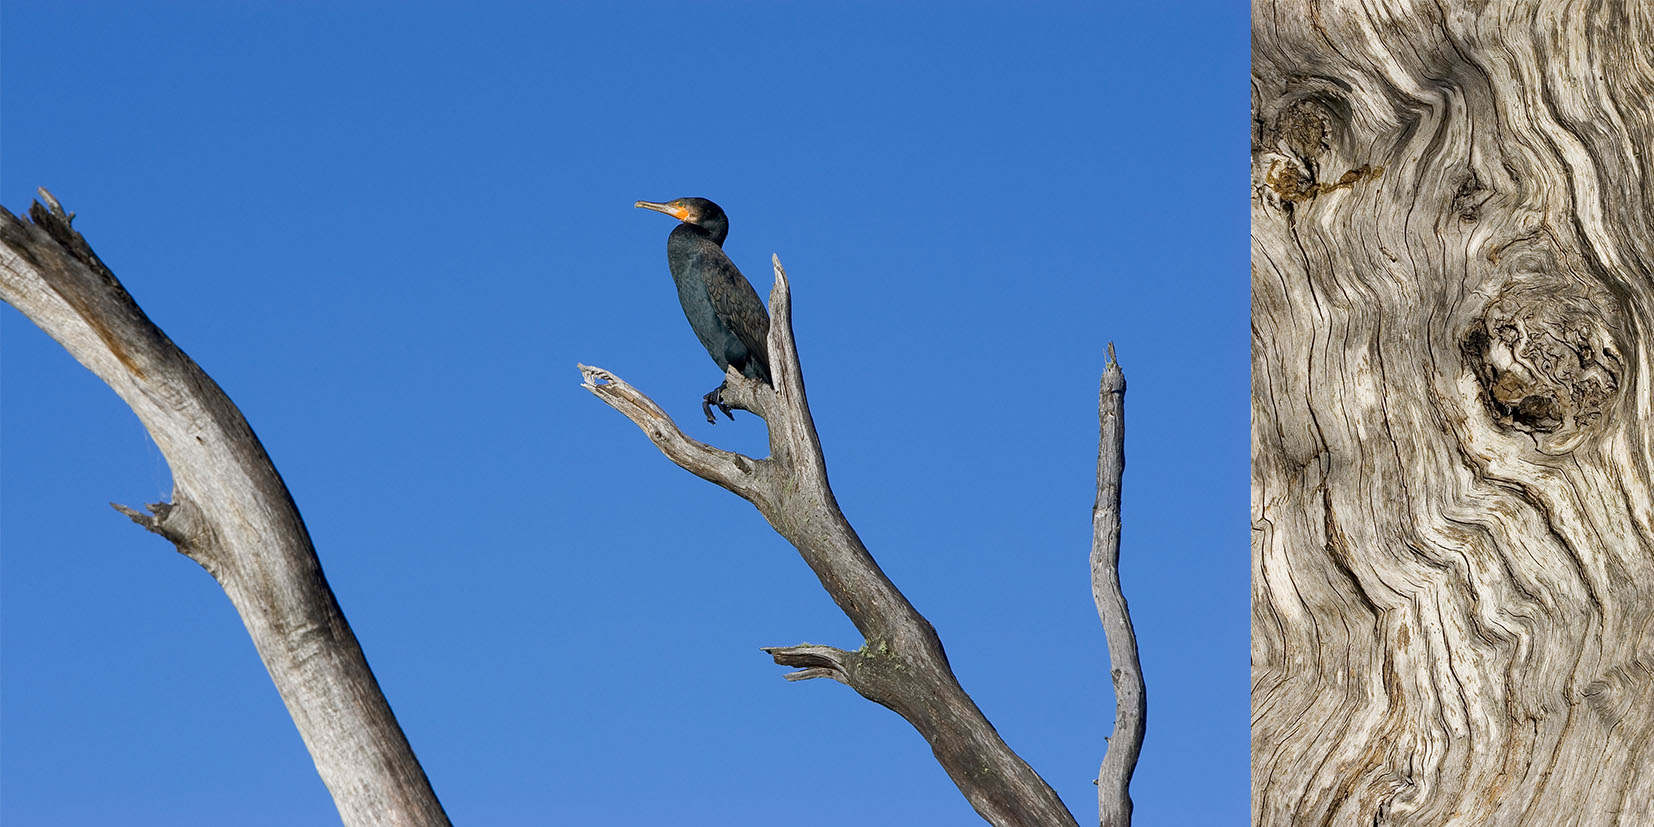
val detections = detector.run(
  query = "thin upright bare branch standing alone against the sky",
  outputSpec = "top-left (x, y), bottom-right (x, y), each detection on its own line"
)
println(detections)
top-left (1092, 344), bottom-right (1148, 827)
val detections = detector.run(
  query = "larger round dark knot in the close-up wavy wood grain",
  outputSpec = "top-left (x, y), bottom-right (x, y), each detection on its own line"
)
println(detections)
top-left (1460, 273), bottom-right (1626, 450)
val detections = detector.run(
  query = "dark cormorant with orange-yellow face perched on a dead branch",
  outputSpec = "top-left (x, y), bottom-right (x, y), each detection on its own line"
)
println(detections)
top-left (633, 198), bottom-right (774, 423)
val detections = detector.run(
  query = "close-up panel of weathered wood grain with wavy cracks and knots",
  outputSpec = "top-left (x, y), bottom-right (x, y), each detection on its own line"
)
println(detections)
top-left (1252, 0), bottom-right (1654, 827)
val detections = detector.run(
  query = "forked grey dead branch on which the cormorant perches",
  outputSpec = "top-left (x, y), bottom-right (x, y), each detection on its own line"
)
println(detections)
top-left (581, 260), bottom-right (1075, 827)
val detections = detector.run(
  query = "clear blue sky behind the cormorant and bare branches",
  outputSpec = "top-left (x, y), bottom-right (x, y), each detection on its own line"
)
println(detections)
top-left (0, 0), bottom-right (1249, 827)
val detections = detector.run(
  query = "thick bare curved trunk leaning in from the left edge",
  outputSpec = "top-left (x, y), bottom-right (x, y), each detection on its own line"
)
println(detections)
top-left (0, 190), bottom-right (448, 827)
